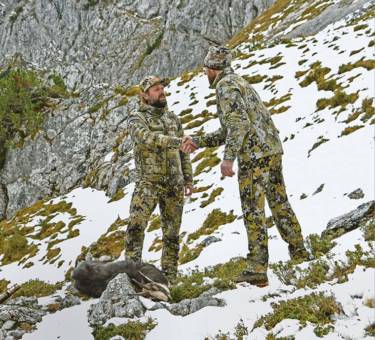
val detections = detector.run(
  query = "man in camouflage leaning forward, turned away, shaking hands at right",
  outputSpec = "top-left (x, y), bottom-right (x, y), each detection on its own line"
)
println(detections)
top-left (182, 47), bottom-right (308, 286)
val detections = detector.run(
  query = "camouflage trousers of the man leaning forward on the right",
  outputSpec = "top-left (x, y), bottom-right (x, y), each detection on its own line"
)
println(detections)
top-left (238, 154), bottom-right (303, 272)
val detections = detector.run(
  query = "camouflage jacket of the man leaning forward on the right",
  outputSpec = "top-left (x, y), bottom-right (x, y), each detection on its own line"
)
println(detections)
top-left (193, 67), bottom-right (283, 161)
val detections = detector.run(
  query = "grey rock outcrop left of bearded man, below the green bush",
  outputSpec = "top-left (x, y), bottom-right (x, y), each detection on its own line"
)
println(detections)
top-left (0, 84), bottom-right (136, 218)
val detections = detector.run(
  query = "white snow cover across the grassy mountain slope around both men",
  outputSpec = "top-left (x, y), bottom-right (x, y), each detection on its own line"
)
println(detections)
top-left (0, 2), bottom-right (375, 340)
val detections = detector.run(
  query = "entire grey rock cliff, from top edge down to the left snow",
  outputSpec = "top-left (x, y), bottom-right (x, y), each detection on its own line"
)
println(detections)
top-left (0, 0), bottom-right (274, 219)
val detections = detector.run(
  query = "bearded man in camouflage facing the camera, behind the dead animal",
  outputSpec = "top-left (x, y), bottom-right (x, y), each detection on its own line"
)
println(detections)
top-left (125, 76), bottom-right (193, 280)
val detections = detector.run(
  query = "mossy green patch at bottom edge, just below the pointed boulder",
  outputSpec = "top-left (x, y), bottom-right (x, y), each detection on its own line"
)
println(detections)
top-left (92, 318), bottom-right (156, 340)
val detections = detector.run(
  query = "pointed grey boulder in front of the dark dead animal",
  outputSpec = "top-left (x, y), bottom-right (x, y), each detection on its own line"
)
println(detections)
top-left (88, 273), bottom-right (145, 326)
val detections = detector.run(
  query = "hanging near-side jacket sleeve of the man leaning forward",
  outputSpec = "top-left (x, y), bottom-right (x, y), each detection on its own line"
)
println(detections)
top-left (217, 84), bottom-right (251, 161)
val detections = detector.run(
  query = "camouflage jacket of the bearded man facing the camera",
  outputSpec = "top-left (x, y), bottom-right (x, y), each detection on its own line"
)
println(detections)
top-left (127, 102), bottom-right (193, 184)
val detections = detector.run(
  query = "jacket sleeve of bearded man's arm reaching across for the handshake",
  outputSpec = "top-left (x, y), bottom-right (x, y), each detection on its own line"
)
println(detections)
top-left (127, 112), bottom-right (182, 149)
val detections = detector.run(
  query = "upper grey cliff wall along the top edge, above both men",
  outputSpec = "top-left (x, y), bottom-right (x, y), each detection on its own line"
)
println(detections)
top-left (0, 0), bottom-right (274, 87)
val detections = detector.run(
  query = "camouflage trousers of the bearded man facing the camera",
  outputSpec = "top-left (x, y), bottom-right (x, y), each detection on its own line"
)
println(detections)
top-left (125, 182), bottom-right (184, 278)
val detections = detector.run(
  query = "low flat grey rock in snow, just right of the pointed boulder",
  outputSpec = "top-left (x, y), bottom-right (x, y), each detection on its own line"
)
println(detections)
top-left (150, 288), bottom-right (226, 316)
